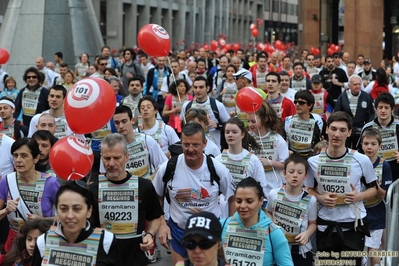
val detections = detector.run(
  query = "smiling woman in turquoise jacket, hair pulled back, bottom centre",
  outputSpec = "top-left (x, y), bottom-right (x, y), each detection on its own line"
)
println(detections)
top-left (220, 177), bottom-right (294, 266)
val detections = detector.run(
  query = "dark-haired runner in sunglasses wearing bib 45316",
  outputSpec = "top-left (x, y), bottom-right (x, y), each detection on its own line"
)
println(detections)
top-left (284, 90), bottom-right (325, 158)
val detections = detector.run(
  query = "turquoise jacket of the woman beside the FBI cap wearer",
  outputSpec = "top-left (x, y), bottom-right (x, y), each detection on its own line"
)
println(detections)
top-left (220, 210), bottom-right (294, 266)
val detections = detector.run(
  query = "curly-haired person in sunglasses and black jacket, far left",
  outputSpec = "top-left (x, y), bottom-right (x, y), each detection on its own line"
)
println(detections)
top-left (14, 67), bottom-right (50, 126)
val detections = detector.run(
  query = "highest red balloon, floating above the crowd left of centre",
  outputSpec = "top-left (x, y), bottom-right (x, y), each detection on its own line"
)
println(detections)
top-left (137, 24), bottom-right (170, 56)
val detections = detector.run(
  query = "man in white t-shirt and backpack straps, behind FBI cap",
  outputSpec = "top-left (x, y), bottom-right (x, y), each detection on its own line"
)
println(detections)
top-left (153, 122), bottom-right (235, 265)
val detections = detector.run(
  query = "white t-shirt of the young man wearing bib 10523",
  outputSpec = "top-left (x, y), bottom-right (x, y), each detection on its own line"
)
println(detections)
top-left (304, 151), bottom-right (377, 231)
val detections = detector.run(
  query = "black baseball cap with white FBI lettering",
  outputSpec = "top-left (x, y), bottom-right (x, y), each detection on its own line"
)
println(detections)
top-left (183, 212), bottom-right (222, 241)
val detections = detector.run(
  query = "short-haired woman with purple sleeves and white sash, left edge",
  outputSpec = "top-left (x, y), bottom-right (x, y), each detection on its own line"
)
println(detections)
top-left (0, 138), bottom-right (60, 262)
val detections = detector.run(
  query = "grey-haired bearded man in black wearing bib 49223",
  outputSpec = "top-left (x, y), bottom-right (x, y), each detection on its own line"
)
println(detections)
top-left (91, 134), bottom-right (166, 266)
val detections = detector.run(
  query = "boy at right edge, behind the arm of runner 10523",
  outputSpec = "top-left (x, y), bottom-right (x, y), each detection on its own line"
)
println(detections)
top-left (362, 128), bottom-right (392, 266)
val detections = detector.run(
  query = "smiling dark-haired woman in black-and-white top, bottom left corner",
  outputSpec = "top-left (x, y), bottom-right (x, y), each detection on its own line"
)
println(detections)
top-left (32, 180), bottom-right (123, 266)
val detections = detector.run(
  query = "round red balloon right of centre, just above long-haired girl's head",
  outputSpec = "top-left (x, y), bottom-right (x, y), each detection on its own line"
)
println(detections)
top-left (236, 87), bottom-right (263, 113)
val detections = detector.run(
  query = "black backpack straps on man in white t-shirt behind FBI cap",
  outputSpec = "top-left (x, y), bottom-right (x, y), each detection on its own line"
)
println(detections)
top-left (162, 154), bottom-right (220, 204)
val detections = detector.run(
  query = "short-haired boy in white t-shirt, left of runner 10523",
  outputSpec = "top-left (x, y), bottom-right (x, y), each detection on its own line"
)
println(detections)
top-left (266, 154), bottom-right (317, 266)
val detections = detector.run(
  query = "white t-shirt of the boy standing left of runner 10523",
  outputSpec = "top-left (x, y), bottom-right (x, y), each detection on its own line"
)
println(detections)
top-left (266, 188), bottom-right (317, 253)
